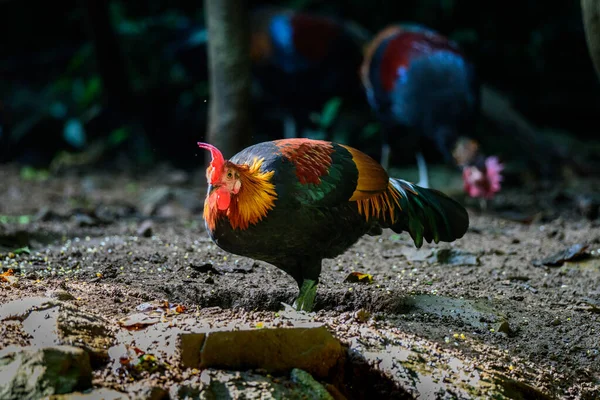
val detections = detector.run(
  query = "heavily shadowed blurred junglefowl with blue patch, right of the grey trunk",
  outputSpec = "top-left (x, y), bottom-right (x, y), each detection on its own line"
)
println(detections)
top-left (250, 7), bottom-right (369, 141)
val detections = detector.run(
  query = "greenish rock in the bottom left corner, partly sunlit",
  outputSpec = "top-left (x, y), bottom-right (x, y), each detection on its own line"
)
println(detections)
top-left (0, 346), bottom-right (92, 400)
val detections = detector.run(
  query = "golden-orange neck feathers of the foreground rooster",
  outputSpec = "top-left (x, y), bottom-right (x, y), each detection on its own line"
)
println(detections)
top-left (204, 158), bottom-right (277, 231)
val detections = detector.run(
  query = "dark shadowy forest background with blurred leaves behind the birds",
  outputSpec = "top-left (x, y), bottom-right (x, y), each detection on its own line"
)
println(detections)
top-left (0, 0), bottom-right (600, 168)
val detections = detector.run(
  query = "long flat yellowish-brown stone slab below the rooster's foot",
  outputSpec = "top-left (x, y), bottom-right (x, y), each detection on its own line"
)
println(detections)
top-left (178, 324), bottom-right (343, 378)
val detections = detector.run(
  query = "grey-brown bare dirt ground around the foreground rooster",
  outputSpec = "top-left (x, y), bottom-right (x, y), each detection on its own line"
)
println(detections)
top-left (0, 166), bottom-right (600, 399)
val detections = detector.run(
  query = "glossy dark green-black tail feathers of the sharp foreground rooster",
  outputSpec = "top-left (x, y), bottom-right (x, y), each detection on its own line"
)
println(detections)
top-left (390, 178), bottom-right (469, 247)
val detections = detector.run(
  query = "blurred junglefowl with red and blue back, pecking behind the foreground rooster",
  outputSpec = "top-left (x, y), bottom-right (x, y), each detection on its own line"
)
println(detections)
top-left (361, 25), bottom-right (502, 199)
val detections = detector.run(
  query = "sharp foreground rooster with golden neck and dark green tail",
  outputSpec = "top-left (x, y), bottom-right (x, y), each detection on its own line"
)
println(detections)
top-left (198, 138), bottom-right (469, 310)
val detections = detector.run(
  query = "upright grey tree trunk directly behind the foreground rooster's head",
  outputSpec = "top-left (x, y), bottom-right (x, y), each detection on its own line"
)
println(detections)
top-left (204, 0), bottom-right (251, 158)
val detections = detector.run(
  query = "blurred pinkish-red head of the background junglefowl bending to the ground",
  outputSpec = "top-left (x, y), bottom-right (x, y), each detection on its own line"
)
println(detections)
top-left (463, 157), bottom-right (504, 199)
